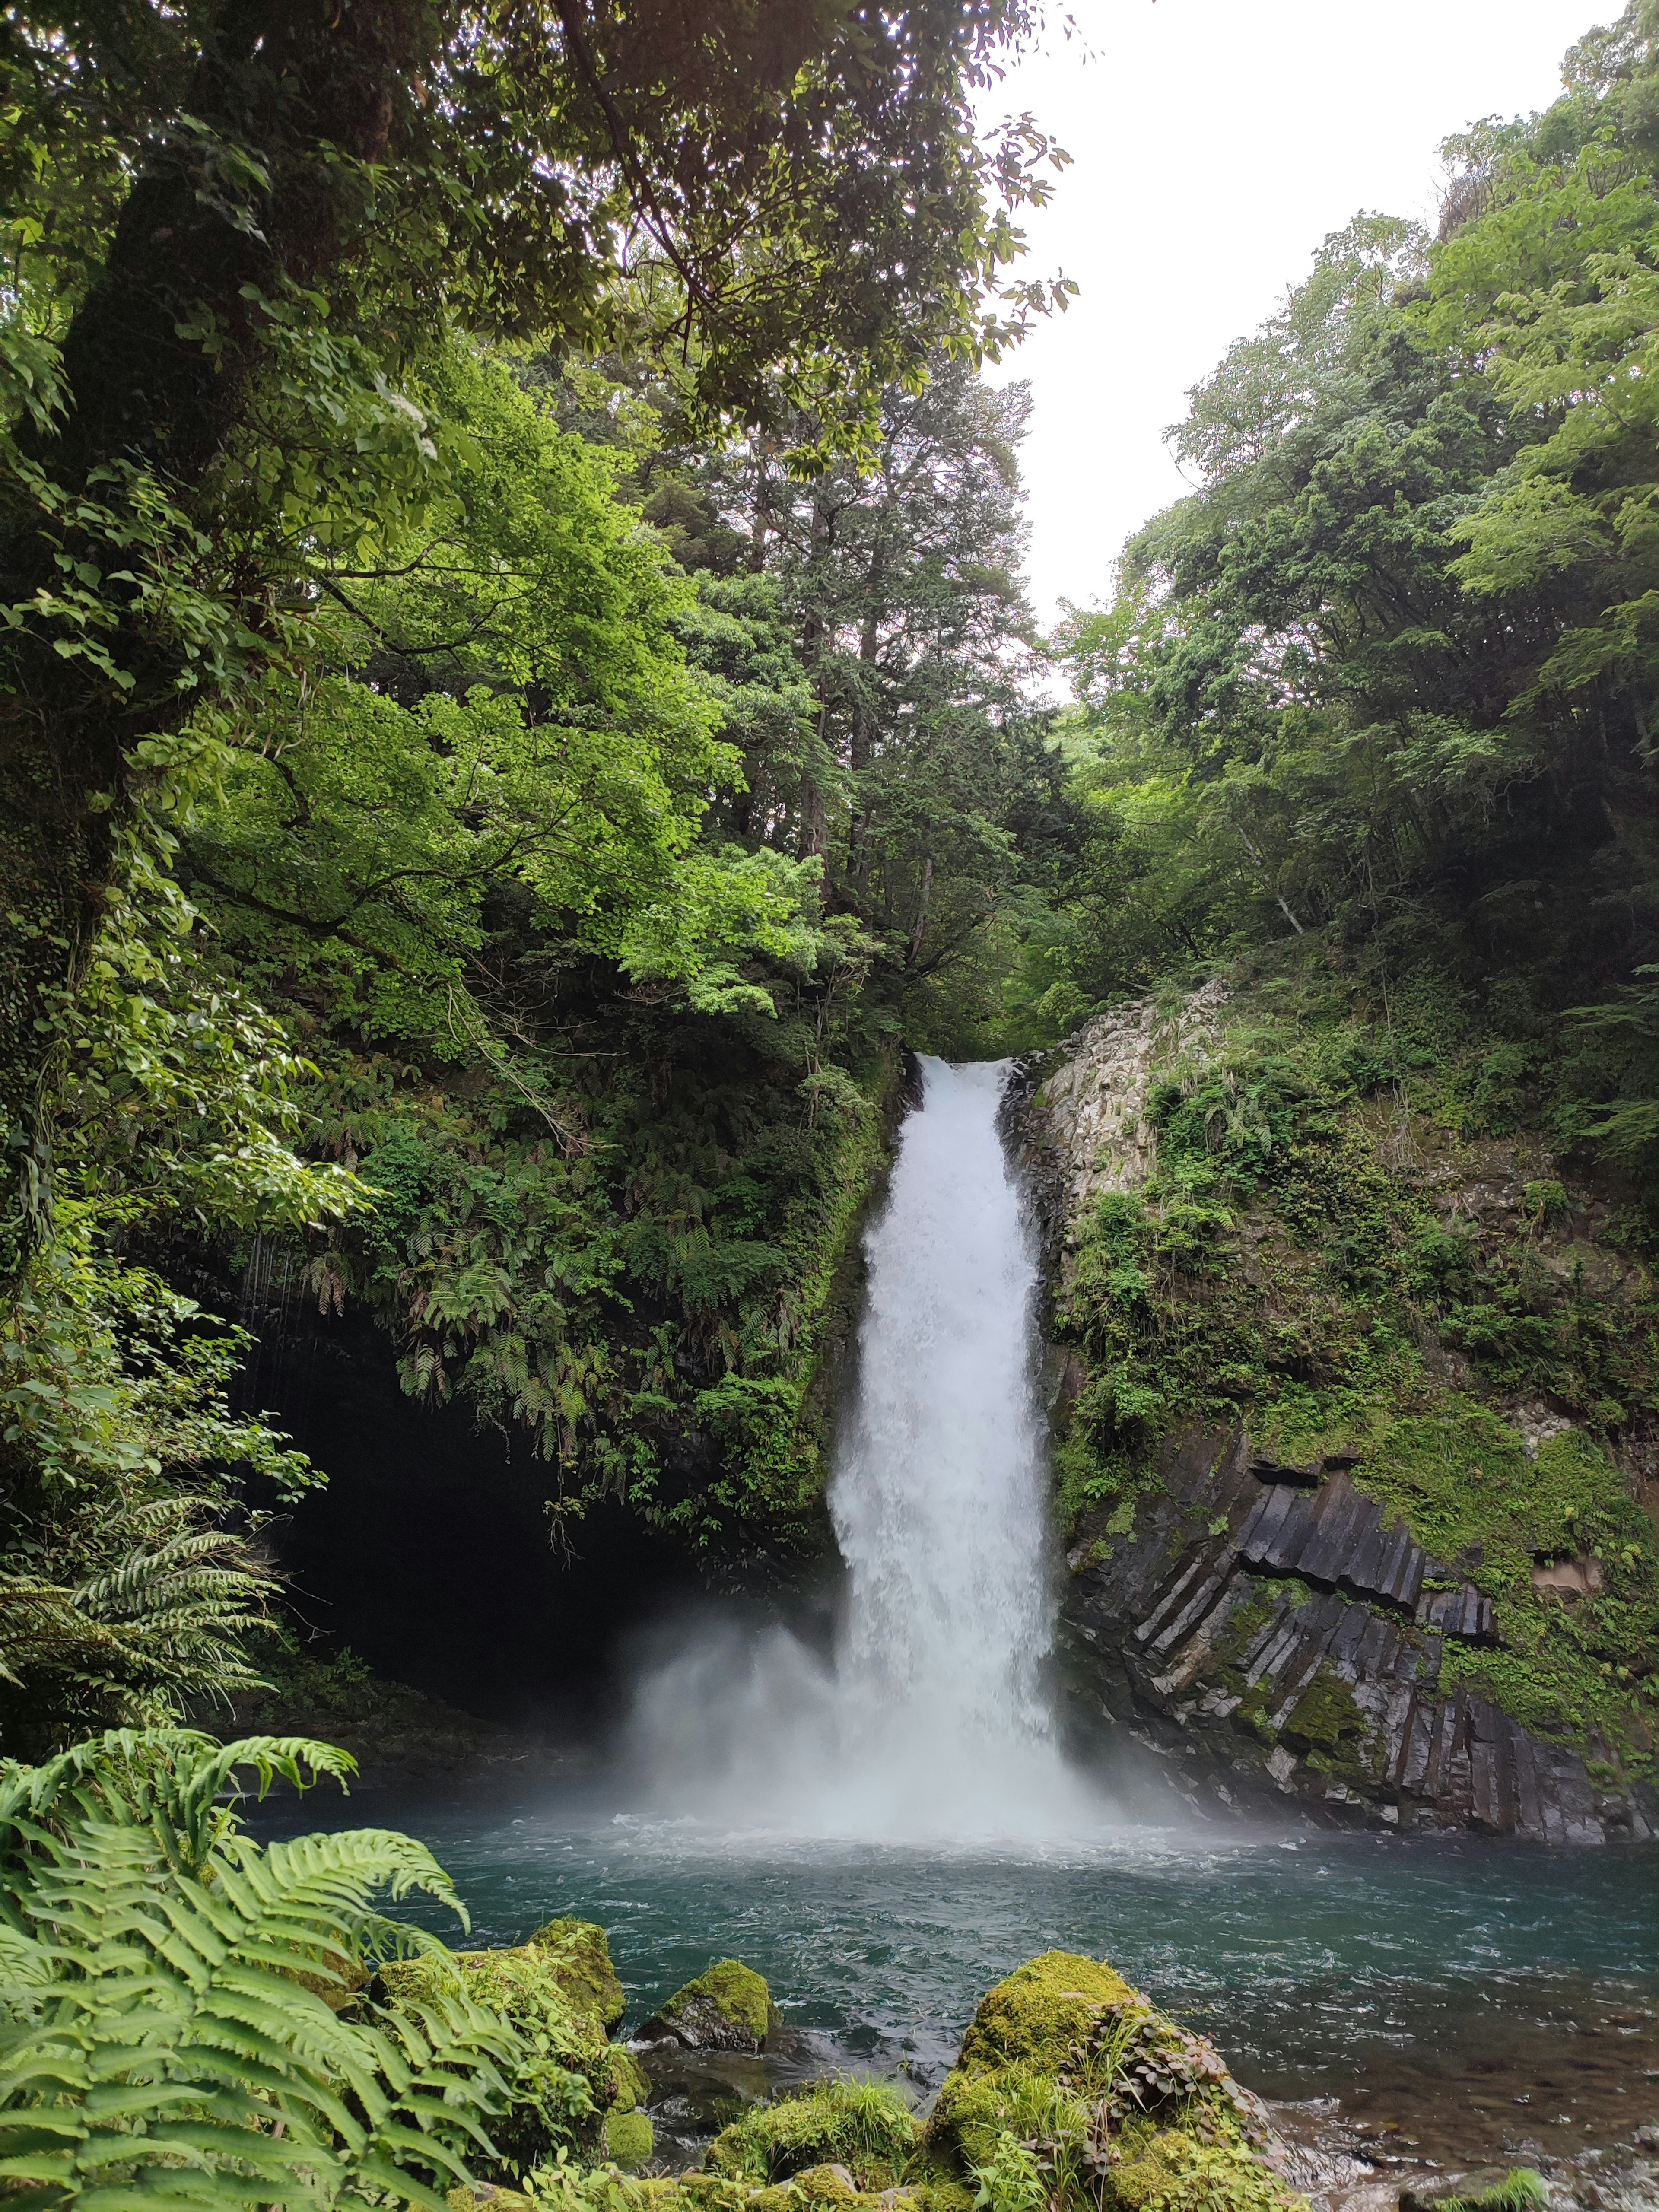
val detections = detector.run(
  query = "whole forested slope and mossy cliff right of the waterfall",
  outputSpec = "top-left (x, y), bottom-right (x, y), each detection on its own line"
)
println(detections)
top-left (1000, 6), bottom-right (1659, 1834)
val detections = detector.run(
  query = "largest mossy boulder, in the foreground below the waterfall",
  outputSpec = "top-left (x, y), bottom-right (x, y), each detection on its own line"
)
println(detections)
top-left (922, 1951), bottom-right (1305, 2212)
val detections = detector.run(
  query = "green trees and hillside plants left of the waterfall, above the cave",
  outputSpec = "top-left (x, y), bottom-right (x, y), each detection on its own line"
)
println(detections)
top-left (0, 0), bottom-right (1079, 1754)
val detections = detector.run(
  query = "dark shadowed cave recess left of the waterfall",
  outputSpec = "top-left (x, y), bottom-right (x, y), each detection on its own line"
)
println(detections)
top-left (239, 1309), bottom-right (699, 1736)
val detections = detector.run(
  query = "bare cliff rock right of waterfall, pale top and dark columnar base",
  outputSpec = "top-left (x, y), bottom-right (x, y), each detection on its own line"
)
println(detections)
top-left (1009, 987), bottom-right (1659, 1843)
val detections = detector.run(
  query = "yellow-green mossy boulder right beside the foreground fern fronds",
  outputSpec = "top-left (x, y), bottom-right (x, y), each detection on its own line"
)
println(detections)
top-left (382, 1942), bottom-right (650, 2183)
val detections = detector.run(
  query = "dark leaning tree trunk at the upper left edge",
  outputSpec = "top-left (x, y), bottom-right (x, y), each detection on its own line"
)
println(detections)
top-left (0, 0), bottom-right (429, 1272)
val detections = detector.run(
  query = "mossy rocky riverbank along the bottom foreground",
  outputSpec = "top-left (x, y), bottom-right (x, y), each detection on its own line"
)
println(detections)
top-left (407, 1920), bottom-right (1659, 2212)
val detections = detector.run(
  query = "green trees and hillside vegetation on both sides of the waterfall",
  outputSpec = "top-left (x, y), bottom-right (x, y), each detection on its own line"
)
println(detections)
top-left (0, 0), bottom-right (1659, 1756)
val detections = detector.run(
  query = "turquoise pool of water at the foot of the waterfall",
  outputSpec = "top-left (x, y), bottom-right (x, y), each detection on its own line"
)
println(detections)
top-left (283, 1794), bottom-right (1659, 2117)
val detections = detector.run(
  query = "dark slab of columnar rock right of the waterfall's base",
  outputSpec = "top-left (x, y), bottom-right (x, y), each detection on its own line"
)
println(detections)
top-left (1062, 1429), bottom-right (1659, 1843)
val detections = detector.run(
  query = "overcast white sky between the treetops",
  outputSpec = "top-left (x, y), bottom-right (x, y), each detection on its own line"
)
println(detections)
top-left (987, 0), bottom-right (1621, 622)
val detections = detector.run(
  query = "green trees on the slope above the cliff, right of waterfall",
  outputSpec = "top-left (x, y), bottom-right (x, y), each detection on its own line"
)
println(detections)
top-left (1017, 24), bottom-right (1659, 1062)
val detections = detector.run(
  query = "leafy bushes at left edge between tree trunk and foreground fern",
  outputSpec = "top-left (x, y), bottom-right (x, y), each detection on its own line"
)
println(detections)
top-left (0, 854), bottom-right (358, 1752)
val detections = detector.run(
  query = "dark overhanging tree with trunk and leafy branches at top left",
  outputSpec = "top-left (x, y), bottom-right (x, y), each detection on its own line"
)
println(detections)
top-left (0, 0), bottom-right (1071, 1243)
